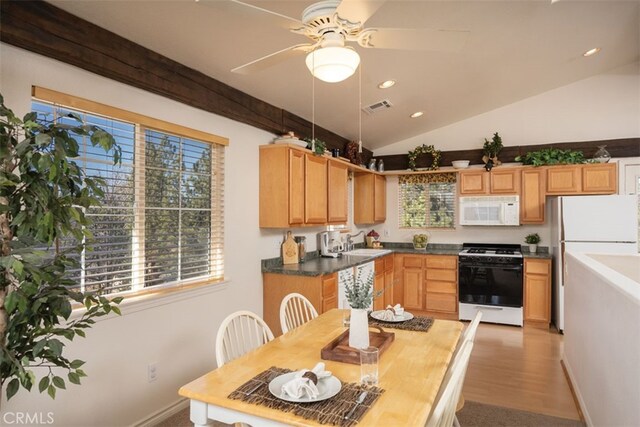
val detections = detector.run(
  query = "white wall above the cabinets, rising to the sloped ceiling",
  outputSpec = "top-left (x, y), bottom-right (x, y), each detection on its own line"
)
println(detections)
top-left (374, 62), bottom-right (640, 157)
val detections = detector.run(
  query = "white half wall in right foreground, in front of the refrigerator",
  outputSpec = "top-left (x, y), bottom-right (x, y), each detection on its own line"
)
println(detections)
top-left (562, 253), bottom-right (640, 426)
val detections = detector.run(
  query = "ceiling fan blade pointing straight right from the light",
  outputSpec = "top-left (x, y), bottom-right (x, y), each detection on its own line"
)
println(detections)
top-left (358, 28), bottom-right (470, 52)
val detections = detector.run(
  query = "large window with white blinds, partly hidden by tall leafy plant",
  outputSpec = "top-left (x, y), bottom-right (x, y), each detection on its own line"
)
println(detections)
top-left (32, 88), bottom-right (227, 295)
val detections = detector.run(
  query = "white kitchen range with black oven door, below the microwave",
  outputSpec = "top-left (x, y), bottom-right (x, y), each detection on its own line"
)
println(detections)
top-left (458, 243), bottom-right (524, 326)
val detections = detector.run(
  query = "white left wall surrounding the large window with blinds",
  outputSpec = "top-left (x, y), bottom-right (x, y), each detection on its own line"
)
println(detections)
top-left (0, 44), bottom-right (330, 426)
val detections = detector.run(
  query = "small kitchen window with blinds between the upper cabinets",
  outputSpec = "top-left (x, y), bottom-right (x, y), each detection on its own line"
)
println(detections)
top-left (398, 173), bottom-right (456, 229)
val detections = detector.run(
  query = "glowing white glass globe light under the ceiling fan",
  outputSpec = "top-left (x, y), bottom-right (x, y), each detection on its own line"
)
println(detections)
top-left (305, 46), bottom-right (360, 83)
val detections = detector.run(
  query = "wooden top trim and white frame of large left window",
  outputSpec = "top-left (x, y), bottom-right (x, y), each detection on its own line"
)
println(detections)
top-left (31, 86), bottom-right (229, 299)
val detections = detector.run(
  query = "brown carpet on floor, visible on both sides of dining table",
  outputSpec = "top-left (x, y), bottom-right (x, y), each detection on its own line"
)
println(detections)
top-left (155, 400), bottom-right (585, 427)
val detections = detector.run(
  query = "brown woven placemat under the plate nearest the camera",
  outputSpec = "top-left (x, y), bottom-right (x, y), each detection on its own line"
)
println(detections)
top-left (227, 366), bottom-right (384, 427)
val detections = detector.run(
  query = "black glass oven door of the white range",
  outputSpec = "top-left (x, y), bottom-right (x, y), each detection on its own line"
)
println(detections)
top-left (458, 259), bottom-right (523, 307)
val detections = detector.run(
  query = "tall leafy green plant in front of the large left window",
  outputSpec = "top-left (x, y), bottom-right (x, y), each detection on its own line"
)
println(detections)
top-left (0, 95), bottom-right (121, 399)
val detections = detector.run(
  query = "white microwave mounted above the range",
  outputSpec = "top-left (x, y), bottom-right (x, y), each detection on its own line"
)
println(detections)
top-left (458, 196), bottom-right (520, 225)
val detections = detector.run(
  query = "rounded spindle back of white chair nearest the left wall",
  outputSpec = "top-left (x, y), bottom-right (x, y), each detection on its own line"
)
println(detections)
top-left (216, 311), bottom-right (273, 367)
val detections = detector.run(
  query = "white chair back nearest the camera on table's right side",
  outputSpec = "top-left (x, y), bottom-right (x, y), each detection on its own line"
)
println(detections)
top-left (426, 341), bottom-right (473, 427)
